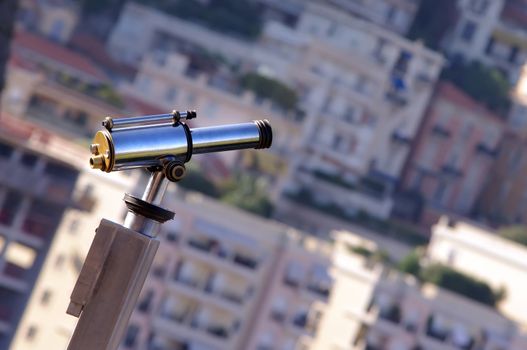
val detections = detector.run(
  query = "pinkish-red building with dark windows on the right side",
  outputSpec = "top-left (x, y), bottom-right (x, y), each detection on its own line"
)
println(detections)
top-left (394, 82), bottom-right (505, 227)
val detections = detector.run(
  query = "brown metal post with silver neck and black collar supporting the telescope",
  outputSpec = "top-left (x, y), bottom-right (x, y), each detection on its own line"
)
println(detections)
top-left (67, 172), bottom-right (175, 350)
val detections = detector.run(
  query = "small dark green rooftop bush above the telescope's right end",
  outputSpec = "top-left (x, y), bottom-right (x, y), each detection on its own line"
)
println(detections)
top-left (240, 73), bottom-right (298, 110)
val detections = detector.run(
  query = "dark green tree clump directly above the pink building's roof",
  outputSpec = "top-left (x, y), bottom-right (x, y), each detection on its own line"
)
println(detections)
top-left (442, 60), bottom-right (510, 115)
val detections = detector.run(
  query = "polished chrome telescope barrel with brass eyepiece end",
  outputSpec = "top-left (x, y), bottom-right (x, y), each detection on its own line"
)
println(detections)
top-left (90, 119), bottom-right (272, 172)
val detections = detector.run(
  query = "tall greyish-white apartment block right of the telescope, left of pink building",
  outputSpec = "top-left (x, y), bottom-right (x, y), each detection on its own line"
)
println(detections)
top-left (270, 6), bottom-right (442, 232)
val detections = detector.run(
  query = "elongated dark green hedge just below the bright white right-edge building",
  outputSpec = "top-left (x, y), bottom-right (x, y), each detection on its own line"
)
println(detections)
top-left (419, 264), bottom-right (504, 306)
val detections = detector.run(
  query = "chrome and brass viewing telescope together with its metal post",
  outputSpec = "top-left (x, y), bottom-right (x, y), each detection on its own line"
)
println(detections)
top-left (67, 111), bottom-right (273, 350)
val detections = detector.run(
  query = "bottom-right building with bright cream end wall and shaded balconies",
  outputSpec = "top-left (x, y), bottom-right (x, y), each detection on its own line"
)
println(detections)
top-left (312, 232), bottom-right (527, 350)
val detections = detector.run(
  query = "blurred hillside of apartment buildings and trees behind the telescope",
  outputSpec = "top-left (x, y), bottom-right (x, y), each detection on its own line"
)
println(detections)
top-left (0, 0), bottom-right (527, 350)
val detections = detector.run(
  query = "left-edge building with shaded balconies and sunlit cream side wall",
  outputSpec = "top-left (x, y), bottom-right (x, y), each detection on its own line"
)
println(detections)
top-left (0, 115), bottom-right (136, 349)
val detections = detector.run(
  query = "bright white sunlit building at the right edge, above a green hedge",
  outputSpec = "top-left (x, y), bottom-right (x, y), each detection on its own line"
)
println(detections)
top-left (427, 217), bottom-right (527, 326)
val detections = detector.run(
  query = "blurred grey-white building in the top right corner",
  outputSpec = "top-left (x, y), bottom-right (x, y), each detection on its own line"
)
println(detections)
top-left (445, 0), bottom-right (527, 82)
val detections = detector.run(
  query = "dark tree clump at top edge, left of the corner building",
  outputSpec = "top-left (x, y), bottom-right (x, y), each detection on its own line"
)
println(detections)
top-left (408, 0), bottom-right (457, 50)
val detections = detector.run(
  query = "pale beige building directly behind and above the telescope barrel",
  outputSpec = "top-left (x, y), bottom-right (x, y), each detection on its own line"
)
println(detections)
top-left (119, 51), bottom-right (302, 181)
